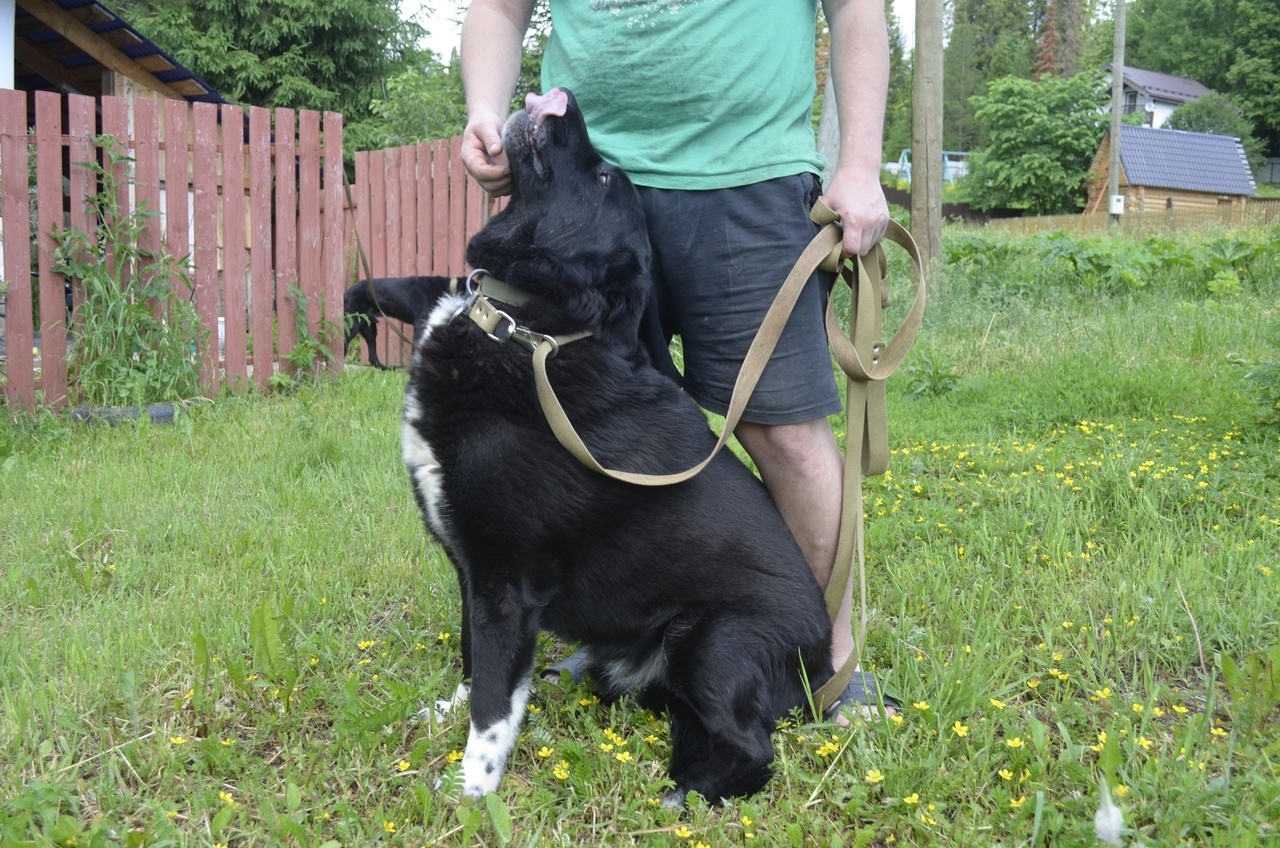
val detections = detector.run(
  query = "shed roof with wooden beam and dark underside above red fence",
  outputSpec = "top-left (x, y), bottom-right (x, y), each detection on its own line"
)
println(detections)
top-left (14, 0), bottom-right (227, 102)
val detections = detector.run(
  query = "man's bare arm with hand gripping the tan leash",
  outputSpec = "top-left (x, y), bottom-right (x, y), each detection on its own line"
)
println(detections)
top-left (822, 0), bottom-right (888, 256)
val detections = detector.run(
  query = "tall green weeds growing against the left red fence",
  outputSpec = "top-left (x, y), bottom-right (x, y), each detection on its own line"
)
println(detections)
top-left (54, 136), bottom-right (206, 406)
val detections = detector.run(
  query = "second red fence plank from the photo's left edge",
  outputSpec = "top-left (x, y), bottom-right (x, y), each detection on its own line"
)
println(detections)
top-left (36, 91), bottom-right (67, 409)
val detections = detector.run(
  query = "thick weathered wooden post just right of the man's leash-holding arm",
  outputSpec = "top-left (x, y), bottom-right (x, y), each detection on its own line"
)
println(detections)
top-left (911, 0), bottom-right (942, 291)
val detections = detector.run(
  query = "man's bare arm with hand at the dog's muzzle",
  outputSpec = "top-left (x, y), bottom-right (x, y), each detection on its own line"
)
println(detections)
top-left (460, 0), bottom-right (535, 195)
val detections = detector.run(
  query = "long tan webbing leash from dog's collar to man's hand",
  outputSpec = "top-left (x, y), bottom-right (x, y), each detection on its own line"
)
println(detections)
top-left (457, 200), bottom-right (925, 715)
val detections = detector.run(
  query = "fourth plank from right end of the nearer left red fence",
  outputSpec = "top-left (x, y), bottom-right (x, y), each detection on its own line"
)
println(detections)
top-left (248, 106), bottom-right (273, 388)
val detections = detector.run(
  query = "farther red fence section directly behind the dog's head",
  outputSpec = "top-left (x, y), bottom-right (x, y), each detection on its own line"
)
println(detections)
top-left (347, 137), bottom-right (504, 365)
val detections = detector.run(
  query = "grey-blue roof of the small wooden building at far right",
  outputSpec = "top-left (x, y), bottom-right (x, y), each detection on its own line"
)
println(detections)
top-left (1120, 124), bottom-right (1257, 195)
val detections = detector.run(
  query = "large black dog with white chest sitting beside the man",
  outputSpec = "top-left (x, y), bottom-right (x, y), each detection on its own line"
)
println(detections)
top-left (402, 90), bottom-right (832, 803)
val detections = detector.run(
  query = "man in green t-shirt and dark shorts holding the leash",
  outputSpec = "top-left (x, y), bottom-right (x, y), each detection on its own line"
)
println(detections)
top-left (461, 0), bottom-right (888, 705)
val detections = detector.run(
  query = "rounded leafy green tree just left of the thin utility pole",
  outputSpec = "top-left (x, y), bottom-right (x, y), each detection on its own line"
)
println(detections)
top-left (969, 72), bottom-right (1106, 215)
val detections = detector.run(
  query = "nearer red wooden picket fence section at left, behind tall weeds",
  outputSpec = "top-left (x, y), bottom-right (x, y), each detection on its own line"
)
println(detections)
top-left (0, 90), bottom-right (349, 409)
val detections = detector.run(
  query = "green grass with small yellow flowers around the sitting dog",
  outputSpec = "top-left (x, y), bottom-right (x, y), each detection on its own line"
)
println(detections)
top-left (0, 249), bottom-right (1280, 847)
